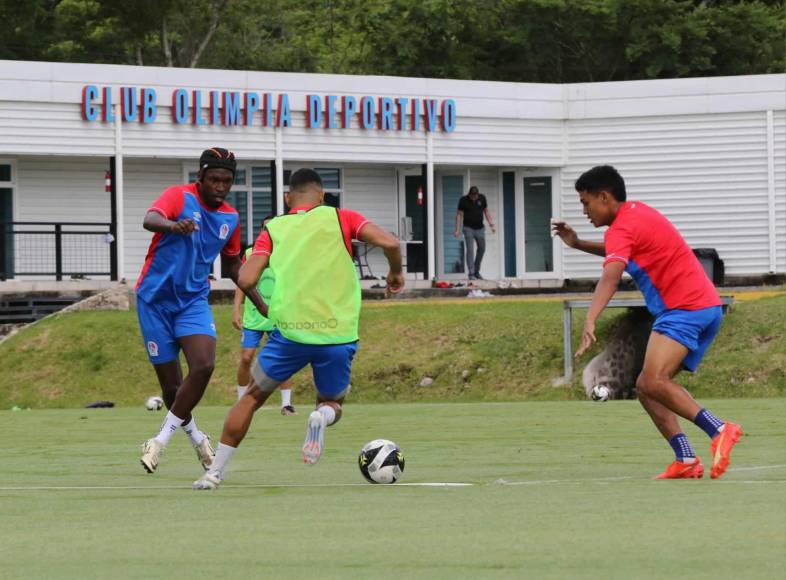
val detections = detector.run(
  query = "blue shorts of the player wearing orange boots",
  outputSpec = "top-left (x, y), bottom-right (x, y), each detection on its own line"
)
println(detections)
top-left (652, 306), bottom-right (723, 372)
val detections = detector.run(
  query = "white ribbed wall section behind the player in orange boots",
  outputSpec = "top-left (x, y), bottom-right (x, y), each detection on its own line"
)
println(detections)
top-left (562, 112), bottom-right (768, 278)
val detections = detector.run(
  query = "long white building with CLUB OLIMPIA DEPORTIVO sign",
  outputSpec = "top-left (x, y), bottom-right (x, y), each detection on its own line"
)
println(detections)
top-left (0, 61), bottom-right (786, 286)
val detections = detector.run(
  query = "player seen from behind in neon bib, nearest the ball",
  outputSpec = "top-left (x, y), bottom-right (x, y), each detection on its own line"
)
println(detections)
top-left (194, 169), bottom-right (404, 490)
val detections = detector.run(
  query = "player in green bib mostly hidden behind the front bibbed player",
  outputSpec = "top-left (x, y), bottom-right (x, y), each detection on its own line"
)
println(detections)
top-left (232, 216), bottom-right (295, 415)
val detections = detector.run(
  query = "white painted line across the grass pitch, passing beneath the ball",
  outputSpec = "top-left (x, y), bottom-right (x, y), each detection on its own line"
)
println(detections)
top-left (0, 464), bottom-right (786, 492)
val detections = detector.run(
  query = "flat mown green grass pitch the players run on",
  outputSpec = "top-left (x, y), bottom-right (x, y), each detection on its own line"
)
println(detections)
top-left (0, 399), bottom-right (786, 579)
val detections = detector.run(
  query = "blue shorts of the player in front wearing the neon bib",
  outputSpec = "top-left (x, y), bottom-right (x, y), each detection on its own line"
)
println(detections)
top-left (258, 330), bottom-right (358, 399)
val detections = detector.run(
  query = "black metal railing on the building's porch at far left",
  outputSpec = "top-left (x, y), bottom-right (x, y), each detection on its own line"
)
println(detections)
top-left (0, 222), bottom-right (117, 280)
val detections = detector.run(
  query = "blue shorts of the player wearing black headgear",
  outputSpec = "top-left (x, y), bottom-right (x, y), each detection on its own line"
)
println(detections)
top-left (136, 299), bottom-right (216, 365)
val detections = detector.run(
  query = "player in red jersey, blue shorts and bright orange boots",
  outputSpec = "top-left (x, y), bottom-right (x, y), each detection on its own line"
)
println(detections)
top-left (553, 165), bottom-right (742, 479)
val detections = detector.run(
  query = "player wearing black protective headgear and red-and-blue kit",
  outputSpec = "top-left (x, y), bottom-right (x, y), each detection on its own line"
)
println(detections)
top-left (136, 147), bottom-right (253, 473)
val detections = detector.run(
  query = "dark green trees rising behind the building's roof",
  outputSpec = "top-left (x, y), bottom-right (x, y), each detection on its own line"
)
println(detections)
top-left (0, 0), bottom-right (786, 83)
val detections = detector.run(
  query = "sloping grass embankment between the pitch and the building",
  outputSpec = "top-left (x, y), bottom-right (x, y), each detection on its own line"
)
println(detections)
top-left (0, 293), bottom-right (786, 409)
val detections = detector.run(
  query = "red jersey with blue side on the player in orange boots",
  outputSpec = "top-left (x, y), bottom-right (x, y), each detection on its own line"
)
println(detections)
top-left (603, 201), bottom-right (720, 316)
